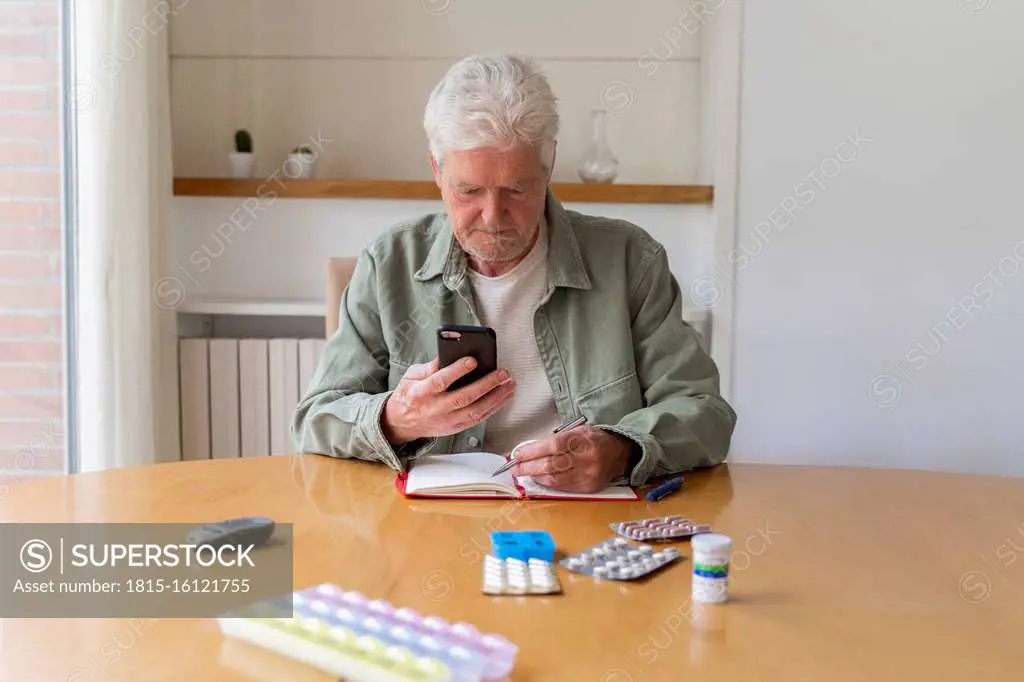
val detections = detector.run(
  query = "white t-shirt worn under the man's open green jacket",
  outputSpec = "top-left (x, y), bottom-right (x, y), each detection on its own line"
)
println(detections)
top-left (468, 218), bottom-right (560, 455)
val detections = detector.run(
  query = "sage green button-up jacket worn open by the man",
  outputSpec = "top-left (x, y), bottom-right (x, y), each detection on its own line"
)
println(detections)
top-left (291, 186), bottom-right (736, 485)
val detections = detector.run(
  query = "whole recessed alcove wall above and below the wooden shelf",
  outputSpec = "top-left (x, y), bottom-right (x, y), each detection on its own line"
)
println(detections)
top-left (165, 0), bottom-right (716, 337)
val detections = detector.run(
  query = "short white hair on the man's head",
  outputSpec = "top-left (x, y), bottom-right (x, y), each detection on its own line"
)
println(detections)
top-left (423, 54), bottom-right (558, 172)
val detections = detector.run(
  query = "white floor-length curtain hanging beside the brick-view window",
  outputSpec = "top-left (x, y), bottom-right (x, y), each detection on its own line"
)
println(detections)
top-left (74, 0), bottom-right (182, 471)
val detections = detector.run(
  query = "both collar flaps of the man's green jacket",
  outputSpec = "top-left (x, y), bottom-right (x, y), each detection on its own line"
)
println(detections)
top-left (414, 187), bottom-right (591, 290)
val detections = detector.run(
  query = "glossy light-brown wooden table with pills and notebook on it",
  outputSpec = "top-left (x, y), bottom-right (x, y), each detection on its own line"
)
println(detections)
top-left (0, 456), bottom-right (1024, 682)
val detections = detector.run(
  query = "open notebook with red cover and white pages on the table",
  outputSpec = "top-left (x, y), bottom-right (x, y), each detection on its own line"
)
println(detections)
top-left (395, 453), bottom-right (638, 500)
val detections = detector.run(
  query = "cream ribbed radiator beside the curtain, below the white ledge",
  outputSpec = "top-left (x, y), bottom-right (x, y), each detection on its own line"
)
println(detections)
top-left (178, 339), bottom-right (326, 460)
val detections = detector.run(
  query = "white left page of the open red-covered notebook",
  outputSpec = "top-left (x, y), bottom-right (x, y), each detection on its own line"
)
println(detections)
top-left (406, 453), bottom-right (517, 495)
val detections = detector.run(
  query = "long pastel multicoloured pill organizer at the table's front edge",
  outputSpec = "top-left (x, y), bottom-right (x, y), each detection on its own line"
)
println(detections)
top-left (218, 584), bottom-right (519, 682)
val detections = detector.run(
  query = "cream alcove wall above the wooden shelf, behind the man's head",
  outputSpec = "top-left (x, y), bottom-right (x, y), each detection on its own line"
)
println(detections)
top-left (171, 0), bottom-right (701, 184)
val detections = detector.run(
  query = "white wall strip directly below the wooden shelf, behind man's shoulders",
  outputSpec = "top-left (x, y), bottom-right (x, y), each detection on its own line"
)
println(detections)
top-left (168, 197), bottom-right (714, 311)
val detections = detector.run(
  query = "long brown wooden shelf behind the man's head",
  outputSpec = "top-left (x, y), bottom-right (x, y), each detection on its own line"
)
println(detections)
top-left (174, 177), bottom-right (715, 204)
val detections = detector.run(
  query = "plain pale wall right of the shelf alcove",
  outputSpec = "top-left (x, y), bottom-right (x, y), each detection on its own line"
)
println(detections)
top-left (731, 0), bottom-right (1024, 475)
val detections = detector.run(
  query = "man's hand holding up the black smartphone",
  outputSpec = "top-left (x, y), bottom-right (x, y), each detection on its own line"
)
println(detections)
top-left (381, 357), bottom-right (515, 445)
